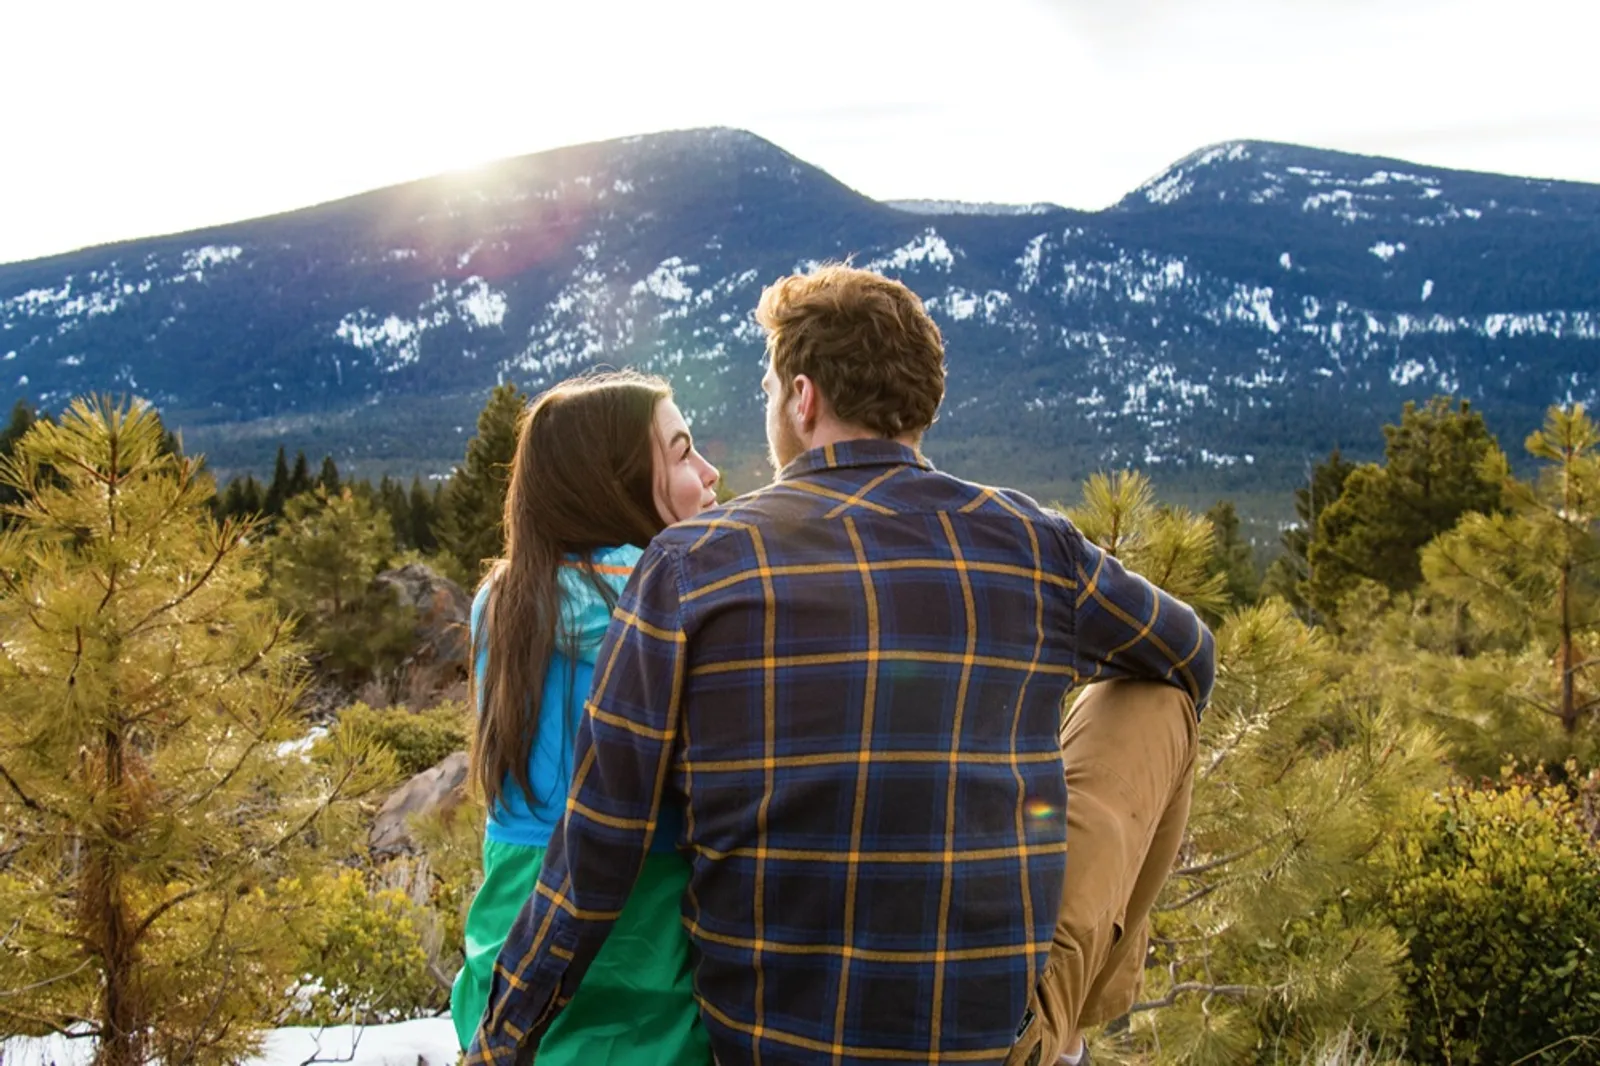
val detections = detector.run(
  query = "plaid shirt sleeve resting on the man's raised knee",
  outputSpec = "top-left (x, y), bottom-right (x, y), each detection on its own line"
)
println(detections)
top-left (1062, 522), bottom-right (1216, 714)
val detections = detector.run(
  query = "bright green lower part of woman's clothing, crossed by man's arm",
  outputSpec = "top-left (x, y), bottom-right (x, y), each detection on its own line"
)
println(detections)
top-left (450, 840), bottom-right (710, 1066)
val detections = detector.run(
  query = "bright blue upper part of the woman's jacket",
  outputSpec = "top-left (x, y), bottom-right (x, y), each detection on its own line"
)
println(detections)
top-left (472, 544), bottom-right (682, 852)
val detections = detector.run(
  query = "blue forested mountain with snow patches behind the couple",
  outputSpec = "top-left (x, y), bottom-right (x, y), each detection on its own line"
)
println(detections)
top-left (0, 130), bottom-right (1600, 493)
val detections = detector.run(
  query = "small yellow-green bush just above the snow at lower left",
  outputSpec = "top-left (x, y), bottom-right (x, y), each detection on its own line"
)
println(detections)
top-left (280, 869), bottom-right (446, 1024)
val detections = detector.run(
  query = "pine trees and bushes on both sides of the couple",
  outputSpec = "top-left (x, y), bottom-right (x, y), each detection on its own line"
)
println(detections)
top-left (0, 386), bottom-right (1600, 1066)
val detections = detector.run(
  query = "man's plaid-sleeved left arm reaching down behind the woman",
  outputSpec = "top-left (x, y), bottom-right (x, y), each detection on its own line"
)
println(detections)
top-left (466, 547), bottom-right (685, 1066)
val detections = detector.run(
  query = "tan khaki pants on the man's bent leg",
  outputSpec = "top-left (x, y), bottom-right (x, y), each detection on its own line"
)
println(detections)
top-left (1006, 680), bottom-right (1195, 1066)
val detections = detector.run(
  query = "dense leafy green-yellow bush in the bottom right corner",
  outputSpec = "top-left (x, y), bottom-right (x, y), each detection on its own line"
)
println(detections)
top-left (1381, 784), bottom-right (1600, 1066)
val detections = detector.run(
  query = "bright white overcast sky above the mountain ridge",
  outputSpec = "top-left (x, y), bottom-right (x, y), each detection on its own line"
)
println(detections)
top-left (0, 0), bottom-right (1600, 262)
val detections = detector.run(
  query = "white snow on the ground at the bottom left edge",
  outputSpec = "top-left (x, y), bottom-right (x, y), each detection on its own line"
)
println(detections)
top-left (0, 1016), bottom-right (461, 1066)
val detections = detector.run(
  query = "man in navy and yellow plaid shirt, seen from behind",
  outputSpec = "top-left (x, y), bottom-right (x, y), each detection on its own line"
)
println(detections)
top-left (467, 266), bottom-right (1213, 1066)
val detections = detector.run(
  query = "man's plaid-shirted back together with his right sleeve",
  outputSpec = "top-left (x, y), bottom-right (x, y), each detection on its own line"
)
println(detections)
top-left (643, 440), bottom-right (1203, 1066)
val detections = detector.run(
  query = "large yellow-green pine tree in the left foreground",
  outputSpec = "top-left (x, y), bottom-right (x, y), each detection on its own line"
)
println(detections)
top-left (0, 393), bottom-right (392, 1066)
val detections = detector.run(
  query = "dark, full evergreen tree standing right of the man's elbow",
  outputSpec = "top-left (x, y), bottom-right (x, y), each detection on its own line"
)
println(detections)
top-left (1306, 397), bottom-right (1501, 619)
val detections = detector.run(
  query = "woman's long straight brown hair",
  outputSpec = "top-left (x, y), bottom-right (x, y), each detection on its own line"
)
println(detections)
top-left (472, 371), bottom-right (672, 810)
